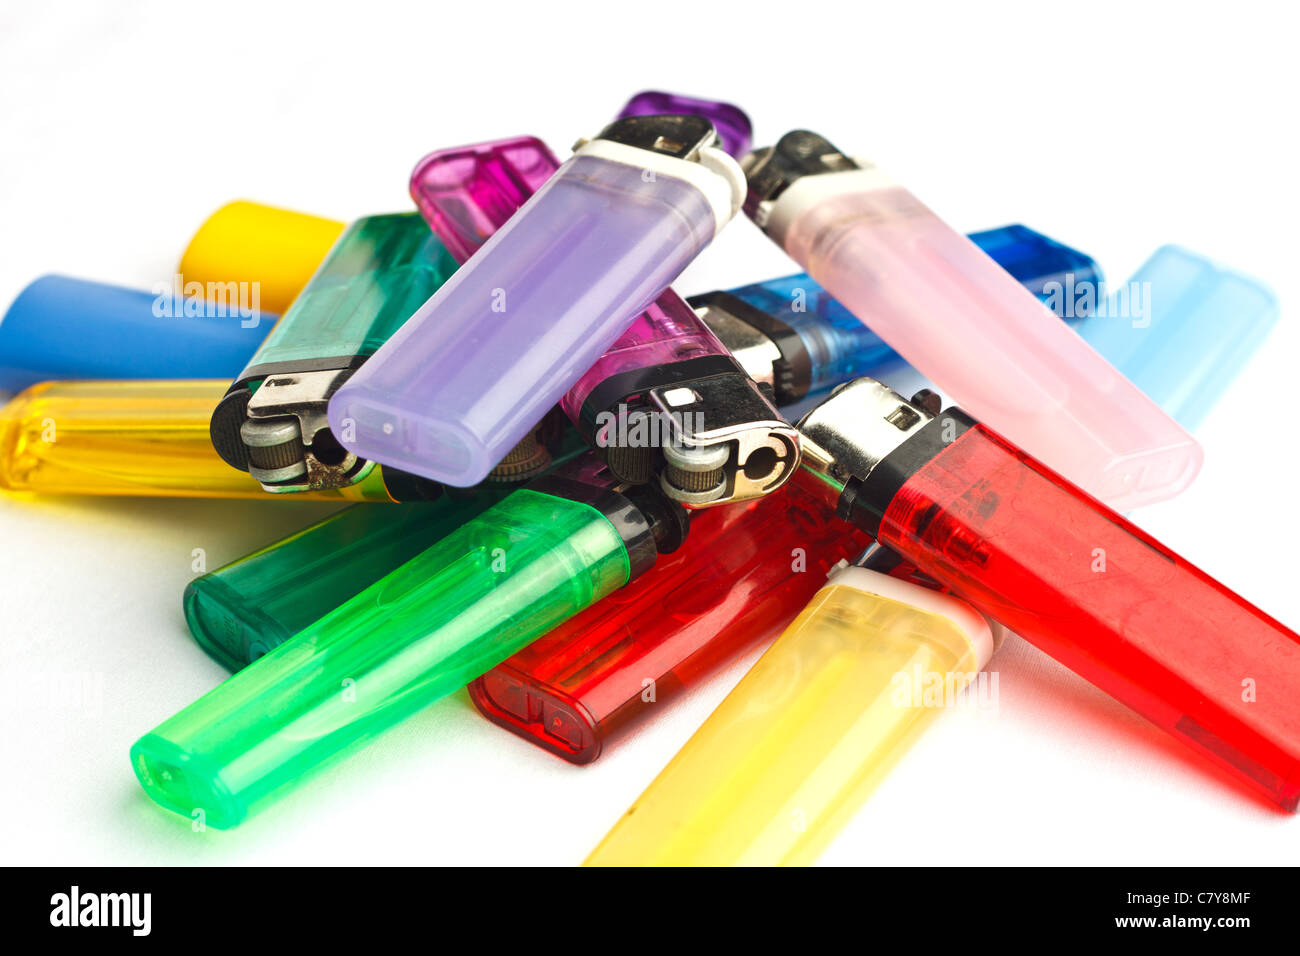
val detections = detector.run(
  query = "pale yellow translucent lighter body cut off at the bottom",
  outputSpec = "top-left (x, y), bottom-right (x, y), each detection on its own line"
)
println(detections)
top-left (586, 571), bottom-right (979, 866)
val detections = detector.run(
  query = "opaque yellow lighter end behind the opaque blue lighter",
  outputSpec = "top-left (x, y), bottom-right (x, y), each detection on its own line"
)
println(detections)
top-left (179, 202), bottom-right (343, 316)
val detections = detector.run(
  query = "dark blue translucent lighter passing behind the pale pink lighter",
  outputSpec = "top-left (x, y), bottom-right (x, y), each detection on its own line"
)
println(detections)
top-left (689, 225), bottom-right (1105, 406)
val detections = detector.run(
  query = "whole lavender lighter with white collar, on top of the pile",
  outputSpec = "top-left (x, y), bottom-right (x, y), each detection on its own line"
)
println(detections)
top-left (329, 117), bottom-right (741, 485)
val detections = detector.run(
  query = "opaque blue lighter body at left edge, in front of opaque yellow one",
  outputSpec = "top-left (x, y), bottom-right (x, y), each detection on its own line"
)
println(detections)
top-left (0, 276), bottom-right (276, 392)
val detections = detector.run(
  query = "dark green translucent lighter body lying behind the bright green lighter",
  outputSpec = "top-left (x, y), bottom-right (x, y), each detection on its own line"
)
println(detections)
top-left (183, 496), bottom-right (504, 671)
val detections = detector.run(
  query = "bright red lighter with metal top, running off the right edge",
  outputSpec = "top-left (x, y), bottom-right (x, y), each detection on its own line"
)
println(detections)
top-left (800, 378), bottom-right (1300, 810)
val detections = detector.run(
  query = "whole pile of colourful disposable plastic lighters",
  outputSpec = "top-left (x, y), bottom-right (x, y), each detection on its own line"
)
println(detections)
top-left (0, 92), bottom-right (1300, 864)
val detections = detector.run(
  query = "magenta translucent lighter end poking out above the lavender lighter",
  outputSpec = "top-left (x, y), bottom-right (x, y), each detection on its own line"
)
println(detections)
top-left (411, 137), bottom-right (560, 263)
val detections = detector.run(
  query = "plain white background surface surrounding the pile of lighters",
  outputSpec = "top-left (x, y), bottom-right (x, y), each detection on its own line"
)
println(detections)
top-left (0, 1), bottom-right (1300, 864)
